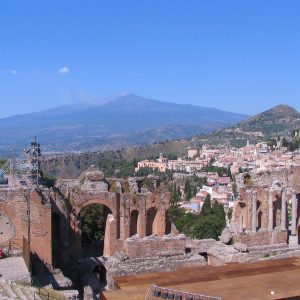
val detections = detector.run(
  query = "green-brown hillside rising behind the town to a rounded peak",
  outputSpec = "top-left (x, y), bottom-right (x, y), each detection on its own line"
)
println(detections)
top-left (42, 105), bottom-right (300, 178)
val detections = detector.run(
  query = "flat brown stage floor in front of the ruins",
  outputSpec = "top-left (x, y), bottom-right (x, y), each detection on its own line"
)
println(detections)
top-left (103, 258), bottom-right (300, 300)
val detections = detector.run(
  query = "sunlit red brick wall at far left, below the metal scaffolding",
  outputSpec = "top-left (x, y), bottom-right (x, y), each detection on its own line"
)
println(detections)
top-left (0, 187), bottom-right (52, 269)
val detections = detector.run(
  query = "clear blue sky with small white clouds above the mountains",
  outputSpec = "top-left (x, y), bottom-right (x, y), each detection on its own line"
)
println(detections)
top-left (0, 0), bottom-right (300, 117)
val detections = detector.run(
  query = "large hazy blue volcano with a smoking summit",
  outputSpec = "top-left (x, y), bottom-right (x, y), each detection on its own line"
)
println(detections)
top-left (0, 94), bottom-right (246, 153)
